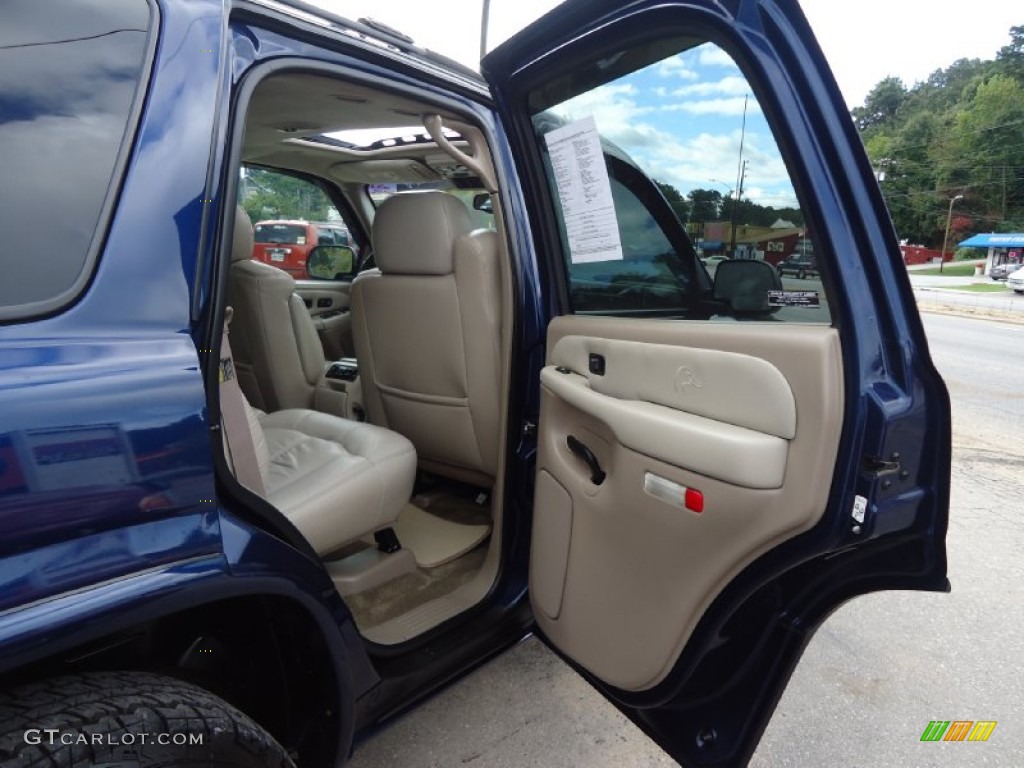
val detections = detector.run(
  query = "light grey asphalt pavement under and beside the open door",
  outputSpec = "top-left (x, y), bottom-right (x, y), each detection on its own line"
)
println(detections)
top-left (351, 314), bottom-right (1024, 768)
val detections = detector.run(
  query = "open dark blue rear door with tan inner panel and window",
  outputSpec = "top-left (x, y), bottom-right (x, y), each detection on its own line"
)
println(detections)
top-left (483, 0), bottom-right (950, 765)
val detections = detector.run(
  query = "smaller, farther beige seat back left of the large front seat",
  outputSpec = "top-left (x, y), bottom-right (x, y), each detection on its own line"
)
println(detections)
top-left (227, 207), bottom-right (327, 412)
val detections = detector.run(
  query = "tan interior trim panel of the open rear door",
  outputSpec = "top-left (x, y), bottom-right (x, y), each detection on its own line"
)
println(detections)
top-left (530, 316), bottom-right (843, 690)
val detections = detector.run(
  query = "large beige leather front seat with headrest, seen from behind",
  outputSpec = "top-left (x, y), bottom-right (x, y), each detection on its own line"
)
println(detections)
top-left (352, 191), bottom-right (502, 485)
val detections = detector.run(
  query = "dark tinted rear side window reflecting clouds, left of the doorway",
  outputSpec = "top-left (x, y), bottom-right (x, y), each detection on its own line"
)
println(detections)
top-left (0, 0), bottom-right (151, 318)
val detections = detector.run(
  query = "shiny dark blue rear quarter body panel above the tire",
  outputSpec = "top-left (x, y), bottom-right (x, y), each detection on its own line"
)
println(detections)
top-left (0, 0), bottom-right (375, 692)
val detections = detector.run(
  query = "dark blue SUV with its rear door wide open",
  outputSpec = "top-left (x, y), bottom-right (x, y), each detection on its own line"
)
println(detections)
top-left (0, 0), bottom-right (950, 768)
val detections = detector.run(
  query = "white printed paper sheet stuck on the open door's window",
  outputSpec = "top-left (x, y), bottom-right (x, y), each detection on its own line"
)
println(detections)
top-left (544, 117), bottom-right (623, 264)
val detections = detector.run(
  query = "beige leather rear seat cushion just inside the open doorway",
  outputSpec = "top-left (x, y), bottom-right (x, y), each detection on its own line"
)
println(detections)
top-left (243, 399), bottom-right (416, 555)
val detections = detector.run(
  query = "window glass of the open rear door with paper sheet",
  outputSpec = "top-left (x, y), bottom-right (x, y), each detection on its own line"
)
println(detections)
top-left (530, 40), bottom-right (830, 323)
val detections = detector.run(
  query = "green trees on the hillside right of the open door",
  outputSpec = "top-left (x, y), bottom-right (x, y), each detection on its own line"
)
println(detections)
top-left (853, 26), bottom-right (1024, 247)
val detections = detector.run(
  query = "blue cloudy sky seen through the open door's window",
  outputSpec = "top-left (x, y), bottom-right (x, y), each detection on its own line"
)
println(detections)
top-left (552, 43), bottom-right (797, 207)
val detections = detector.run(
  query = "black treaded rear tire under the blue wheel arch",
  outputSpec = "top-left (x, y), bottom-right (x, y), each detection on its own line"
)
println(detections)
top-left (0, 672), bottom-right (295, 768)
